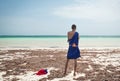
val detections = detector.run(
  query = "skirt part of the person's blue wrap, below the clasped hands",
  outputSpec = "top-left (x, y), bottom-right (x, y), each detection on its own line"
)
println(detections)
top-left (67, 46), bottom-right (80, 59)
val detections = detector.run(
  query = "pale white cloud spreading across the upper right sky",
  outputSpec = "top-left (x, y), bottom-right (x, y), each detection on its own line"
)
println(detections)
top-left (53, 0), bottom-right (120, 22)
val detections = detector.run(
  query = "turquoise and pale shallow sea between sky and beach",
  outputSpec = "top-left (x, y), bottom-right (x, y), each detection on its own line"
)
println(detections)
top-left (0, 36), bottom-right (120, 48)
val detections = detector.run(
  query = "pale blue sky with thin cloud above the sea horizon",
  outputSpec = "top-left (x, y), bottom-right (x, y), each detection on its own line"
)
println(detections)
top-left (0, 0), bottom-right (120, 35)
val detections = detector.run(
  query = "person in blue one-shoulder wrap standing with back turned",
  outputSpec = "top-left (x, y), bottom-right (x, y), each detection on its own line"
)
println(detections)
top-left (64, 24), bottom-right (80, 76)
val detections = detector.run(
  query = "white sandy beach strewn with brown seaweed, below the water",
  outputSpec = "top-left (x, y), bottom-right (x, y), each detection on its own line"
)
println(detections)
top-left (0, 48), bottom-right (120, 81)
